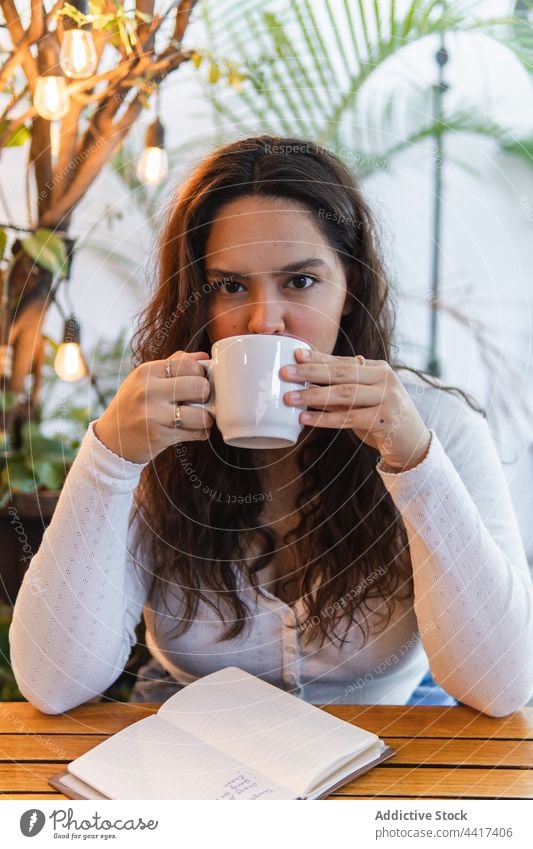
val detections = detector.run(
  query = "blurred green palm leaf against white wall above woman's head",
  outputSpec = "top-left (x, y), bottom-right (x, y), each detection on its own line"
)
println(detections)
top-left (198, 0), bottom-right (533, 167)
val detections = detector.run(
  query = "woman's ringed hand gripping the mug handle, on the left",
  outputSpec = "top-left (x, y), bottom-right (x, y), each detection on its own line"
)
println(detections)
top-left (94, 351), bottom-right (215, 463)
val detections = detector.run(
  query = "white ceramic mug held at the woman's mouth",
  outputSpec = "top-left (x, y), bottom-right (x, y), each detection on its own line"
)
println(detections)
top-left (183, 333), bottom-right (311, 448)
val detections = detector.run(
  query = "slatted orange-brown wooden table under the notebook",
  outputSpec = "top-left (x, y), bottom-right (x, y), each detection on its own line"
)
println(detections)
top-left (0, 702), bottom-right (533, 800)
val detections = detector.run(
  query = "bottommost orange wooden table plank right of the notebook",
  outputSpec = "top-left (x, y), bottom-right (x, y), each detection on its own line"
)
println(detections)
top-left (335, 765), bottom-right (533, 799)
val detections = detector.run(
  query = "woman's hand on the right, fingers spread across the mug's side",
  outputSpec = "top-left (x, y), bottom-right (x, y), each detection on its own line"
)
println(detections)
top-left (279, 348), bottom-right (431, 471)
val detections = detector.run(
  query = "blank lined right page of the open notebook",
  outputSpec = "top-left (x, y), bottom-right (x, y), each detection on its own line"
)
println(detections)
top-left (159, 666), bottom-right (379, 795)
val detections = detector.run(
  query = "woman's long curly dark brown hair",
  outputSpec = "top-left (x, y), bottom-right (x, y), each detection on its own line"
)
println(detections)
top-left (132, 135), bottom-right (436, 644)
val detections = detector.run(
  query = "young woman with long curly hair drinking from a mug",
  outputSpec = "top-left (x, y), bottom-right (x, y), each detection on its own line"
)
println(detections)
top-left (10, 136), bottom-right (533, 716)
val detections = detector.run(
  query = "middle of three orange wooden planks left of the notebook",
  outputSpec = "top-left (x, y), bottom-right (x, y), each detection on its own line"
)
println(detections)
top-left (0, 734), bottom-right (108, 761)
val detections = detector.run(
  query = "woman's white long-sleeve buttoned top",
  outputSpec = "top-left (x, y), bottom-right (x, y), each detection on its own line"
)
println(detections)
top-left (9, 371), bottom-right (533, 716)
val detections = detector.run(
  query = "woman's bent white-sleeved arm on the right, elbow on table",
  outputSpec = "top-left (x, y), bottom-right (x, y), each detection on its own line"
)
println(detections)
top-left (383, 428), bottom-right (533, 716)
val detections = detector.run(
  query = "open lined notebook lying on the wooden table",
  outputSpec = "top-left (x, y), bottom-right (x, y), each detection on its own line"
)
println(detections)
top-left (49, 666), bottom-right (394, 799)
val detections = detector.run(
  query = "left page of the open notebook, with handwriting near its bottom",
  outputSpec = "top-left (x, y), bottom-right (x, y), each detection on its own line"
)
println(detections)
top-left (69, 715), bottom-right (294, 799)
